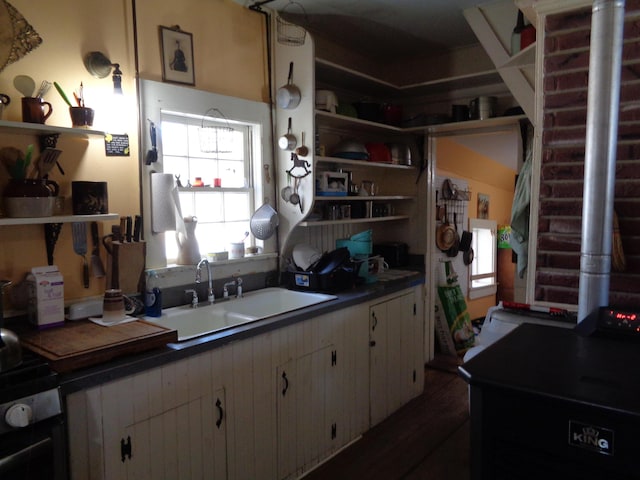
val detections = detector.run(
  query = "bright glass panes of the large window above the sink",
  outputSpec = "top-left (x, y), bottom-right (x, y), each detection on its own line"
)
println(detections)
top-left (160, 111), bottom-right (254, 263)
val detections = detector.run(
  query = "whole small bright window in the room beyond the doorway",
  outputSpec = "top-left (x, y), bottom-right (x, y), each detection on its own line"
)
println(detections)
top-left (468, 218), bottom-right (498, 299)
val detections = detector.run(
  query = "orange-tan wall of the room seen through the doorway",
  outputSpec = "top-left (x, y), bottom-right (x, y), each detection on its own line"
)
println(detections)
top-left (437, 138), bottom-right (517, 318)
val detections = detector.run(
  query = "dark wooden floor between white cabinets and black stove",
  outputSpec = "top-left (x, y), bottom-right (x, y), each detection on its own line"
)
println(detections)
top-left (304, 361), bottom-right (469, 480)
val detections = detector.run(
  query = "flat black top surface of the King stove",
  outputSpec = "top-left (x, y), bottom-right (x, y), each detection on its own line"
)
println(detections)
top-left (459, 323), bottom-right (640, 416)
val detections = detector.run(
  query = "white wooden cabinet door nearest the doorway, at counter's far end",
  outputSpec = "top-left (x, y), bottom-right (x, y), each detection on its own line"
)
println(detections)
top-left (369, 292), bottom-right (424, 426)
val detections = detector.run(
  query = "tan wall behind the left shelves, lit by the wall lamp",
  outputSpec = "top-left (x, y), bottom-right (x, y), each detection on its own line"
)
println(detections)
top-left (0, 0), bottom-right (268, 308)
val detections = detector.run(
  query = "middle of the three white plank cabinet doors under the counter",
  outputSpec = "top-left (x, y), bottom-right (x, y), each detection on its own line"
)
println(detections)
top-left (276, 346), bottom-right (338, 478)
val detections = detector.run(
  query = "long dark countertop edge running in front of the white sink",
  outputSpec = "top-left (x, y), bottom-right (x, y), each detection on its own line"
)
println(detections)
top-left (60, 271), bottom-right (425, 395)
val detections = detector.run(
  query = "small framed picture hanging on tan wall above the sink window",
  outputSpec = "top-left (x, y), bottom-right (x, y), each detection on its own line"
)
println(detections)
top-left (160, 25), bottom-right (196, 85)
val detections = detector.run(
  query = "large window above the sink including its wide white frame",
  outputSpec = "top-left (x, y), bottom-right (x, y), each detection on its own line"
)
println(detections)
top-left (140, 79), bottom-right (277, 272)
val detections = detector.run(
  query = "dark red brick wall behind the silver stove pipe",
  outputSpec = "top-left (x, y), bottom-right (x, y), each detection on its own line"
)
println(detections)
top-left (535, 0), bottom-right (640, 307)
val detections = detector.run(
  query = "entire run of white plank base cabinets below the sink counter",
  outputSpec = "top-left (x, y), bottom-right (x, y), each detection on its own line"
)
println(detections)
top-left (66, 286), bottom-right (423, 480)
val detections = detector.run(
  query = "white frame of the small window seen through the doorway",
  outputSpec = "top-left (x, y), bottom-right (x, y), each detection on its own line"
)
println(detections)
top-left (468, 218), bottom-right (498, 300)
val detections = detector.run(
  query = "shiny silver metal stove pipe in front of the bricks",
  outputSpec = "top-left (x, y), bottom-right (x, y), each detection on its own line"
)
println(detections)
top-left (578, 0), bottom-right (624, 323)
